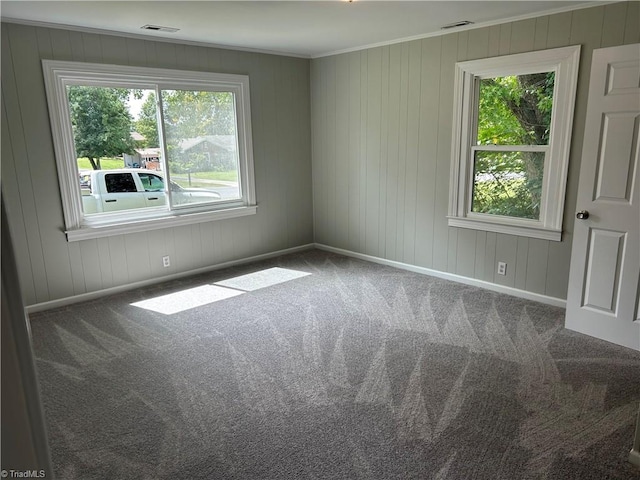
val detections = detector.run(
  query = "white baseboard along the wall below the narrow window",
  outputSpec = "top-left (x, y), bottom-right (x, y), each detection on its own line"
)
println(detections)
top-left (315, 243), bottom-right (567, 308)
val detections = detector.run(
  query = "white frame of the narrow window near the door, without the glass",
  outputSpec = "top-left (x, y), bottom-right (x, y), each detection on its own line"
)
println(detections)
top-left (448, 45), bottom-right (580, 241)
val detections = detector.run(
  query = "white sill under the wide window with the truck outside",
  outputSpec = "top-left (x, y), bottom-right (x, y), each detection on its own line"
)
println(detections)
top-left (65, 205), bottom-right (258, 242)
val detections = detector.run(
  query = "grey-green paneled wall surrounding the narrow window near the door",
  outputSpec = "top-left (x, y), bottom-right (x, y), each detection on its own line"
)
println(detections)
top-left (311, 2), bottom-right (640, 298)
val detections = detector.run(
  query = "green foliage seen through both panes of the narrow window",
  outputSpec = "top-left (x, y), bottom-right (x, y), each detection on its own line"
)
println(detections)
top-left (471, 72), bottom-right (555, 220)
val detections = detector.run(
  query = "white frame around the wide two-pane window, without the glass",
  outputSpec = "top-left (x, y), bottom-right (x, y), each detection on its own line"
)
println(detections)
top-left (42, 60), bottom-right (257, 241)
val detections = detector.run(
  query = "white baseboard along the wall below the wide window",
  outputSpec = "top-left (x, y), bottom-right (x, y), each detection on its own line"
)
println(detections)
top-left (25, 243), bottom-right (315, 314)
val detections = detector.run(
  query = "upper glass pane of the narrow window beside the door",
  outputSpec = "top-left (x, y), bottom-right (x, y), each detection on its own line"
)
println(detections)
top-left (477, 72), bottom-right (555, 145)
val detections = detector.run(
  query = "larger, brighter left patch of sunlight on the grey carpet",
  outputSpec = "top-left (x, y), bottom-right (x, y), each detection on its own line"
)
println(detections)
top-left (131, 285), bottom-right (244, 315)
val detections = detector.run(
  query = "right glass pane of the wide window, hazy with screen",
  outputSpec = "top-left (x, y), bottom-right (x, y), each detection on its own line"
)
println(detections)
top-left (162, 90), bottom-right (242, 205)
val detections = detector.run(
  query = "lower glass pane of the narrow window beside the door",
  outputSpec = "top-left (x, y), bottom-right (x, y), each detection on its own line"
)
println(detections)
top-left (471, 151), bottom-right (545, 220)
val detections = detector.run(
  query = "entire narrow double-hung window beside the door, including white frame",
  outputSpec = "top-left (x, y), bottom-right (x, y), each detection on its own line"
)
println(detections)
top-left (448, 46), bottom-right (580, 240)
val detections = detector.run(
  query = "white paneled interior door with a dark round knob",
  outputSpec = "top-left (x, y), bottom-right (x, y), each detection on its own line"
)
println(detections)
top-left (566, 44), bottom-right (640, 350)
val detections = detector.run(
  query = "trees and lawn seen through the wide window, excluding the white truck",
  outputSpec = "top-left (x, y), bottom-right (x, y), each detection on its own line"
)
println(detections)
top-left (67, 85), bottom-right (241, 213)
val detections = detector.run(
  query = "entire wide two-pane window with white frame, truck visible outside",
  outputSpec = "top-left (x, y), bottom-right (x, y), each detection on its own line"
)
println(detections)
top-left (42, 60), bottom-right (257, 241)
